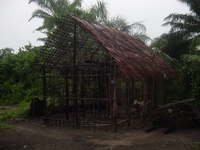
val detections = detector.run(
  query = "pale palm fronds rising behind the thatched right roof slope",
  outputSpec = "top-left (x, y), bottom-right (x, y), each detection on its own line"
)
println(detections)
top-left (87, 1), bottom-right (150, 43)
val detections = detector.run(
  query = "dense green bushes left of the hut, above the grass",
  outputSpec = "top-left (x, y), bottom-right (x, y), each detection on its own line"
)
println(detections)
top-left (0, 44), bottom-right (40, 105)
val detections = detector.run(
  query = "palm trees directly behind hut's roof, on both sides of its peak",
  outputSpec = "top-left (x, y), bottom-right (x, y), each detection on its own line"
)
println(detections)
top-left (29, 0), bottom-right (150, 42)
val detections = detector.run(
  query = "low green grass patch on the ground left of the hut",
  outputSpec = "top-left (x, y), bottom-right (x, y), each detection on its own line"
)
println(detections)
top-left (0, 102), bottom-right (30, 121)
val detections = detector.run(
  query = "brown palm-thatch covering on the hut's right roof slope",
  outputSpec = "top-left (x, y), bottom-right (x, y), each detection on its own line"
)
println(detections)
top-left (35, 15), bottom-right (175, 80)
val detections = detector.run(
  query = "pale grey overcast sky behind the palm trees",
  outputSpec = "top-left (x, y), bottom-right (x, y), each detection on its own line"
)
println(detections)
top-left (0, 0), bottom-right (189, 51)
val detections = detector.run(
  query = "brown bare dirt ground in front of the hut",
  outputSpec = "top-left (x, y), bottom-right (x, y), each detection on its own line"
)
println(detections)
top-left (0, 119), bottom-right (200, 150)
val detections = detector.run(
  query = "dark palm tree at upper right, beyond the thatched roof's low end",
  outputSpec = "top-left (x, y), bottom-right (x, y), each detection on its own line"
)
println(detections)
top-left (151, 0), bottom-right (200, 58)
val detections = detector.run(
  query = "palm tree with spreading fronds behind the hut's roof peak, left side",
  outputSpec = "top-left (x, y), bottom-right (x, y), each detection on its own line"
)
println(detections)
top-left (29, 0), bottom-right (82, 39)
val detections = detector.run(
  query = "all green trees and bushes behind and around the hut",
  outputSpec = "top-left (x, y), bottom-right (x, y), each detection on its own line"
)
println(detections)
top-left (0, 0), bottom-right (200, 116)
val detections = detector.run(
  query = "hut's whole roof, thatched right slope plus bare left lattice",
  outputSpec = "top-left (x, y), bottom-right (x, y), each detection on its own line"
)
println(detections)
top-left (36, 14), bottom-right (176, 80)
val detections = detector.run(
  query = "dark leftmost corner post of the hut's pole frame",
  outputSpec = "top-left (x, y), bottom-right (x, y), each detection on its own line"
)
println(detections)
top-left (42, 67), bottom-right (47, 117)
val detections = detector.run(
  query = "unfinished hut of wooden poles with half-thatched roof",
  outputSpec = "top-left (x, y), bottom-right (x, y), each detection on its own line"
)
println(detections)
top-left (35, 15), bottom-right (174, 132)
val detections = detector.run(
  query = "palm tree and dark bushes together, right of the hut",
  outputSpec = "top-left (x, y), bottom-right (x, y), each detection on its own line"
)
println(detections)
top-left (151, 0), bottom-right (200, 105)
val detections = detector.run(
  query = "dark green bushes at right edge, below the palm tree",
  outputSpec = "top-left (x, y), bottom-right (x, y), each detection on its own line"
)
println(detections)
top-left (165, 54), bottom-right (200, 104)
